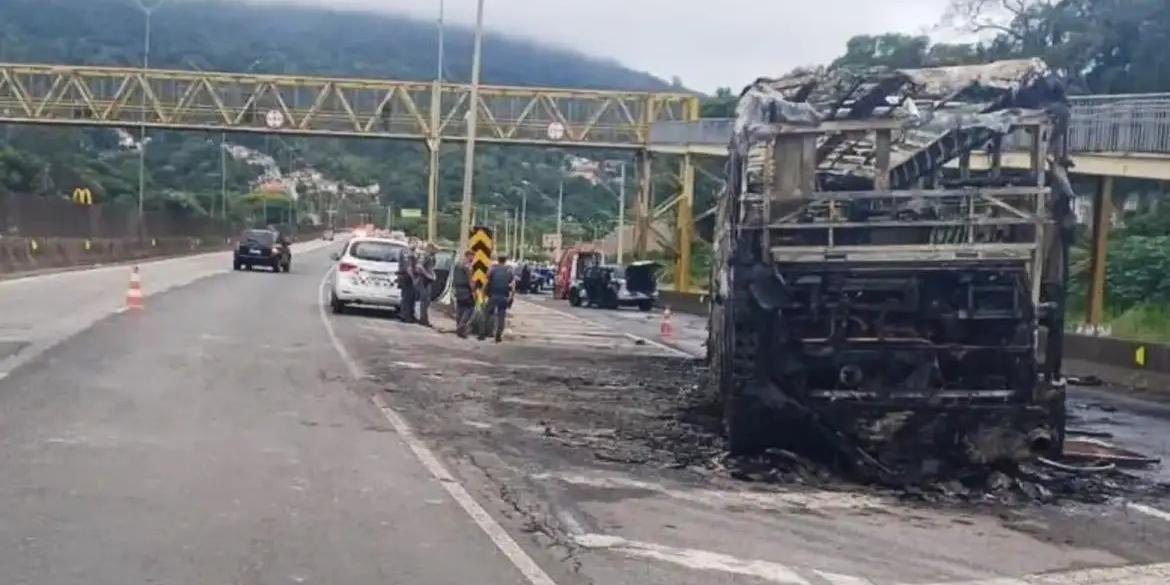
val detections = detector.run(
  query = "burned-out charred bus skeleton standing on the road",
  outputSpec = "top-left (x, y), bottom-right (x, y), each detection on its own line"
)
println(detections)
top-left (708, 61), bottom-right (1072, 474)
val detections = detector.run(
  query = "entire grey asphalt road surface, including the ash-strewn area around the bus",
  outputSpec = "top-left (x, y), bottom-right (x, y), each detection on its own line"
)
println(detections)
top-left (0, 246), bottom-right (1170, 585)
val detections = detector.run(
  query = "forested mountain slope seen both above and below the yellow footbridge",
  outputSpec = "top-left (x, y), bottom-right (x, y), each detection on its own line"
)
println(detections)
top-left (0, 0), bottom-right (670, 236)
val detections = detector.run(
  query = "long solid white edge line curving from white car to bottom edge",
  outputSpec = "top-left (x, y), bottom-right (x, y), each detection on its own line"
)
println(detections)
top-left (317, 268), bottom-right (557, 585)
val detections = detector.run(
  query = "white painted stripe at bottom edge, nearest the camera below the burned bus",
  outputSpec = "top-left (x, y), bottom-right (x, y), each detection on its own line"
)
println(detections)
top-left (573, 535), bottom-right (810, 585)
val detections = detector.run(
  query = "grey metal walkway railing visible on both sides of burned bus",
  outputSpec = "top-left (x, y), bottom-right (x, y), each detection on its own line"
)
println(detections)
top-left (651, 94), bottom-right (1170, 154)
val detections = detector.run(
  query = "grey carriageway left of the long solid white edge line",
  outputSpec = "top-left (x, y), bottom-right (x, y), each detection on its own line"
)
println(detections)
top-left (0, 244), bottom-right (540, 585)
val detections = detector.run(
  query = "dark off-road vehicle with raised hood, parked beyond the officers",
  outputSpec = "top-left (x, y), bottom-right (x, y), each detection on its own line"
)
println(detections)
top-left (569, 261), bottom-right (661, 311)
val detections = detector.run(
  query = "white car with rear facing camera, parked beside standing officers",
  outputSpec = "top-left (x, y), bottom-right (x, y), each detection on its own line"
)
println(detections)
top-left (330, 238), bottom-right (407, 312)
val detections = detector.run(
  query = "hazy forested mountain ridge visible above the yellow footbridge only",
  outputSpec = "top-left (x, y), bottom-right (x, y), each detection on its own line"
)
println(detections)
top-left (0, 0), bottom-right (669, 90)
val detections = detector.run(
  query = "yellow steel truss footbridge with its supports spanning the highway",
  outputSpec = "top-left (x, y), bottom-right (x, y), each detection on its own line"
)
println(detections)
top-left (0, 63), bottom-right (698, 289)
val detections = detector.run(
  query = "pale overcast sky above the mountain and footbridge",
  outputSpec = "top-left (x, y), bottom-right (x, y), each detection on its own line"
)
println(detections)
top-left (268, 0), bottom-right (947, 91)
